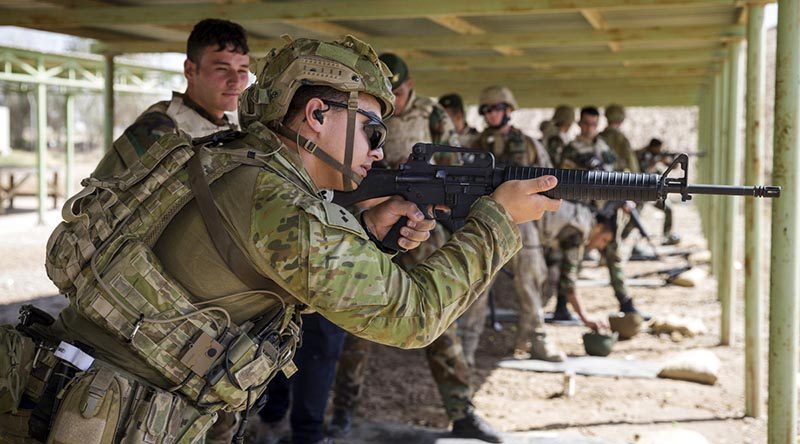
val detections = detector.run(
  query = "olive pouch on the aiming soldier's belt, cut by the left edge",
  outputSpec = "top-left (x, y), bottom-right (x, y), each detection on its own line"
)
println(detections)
top-left (0, 325), bottom-right (36, 415)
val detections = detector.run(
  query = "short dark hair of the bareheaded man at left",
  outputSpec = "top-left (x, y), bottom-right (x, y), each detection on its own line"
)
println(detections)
top-left (186, 19), bottom-right (250, 63)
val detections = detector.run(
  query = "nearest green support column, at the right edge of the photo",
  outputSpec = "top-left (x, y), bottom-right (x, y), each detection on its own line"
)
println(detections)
top-left (767, 0), bottom-right (800, 444)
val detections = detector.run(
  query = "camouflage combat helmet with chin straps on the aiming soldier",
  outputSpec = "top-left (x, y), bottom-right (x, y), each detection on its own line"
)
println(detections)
top-left (239, 36), bottom-right (394, 190)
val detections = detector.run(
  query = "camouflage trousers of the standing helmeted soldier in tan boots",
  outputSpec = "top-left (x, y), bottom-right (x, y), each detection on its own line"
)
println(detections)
top-left (458, 222), bottom-right (547, 363)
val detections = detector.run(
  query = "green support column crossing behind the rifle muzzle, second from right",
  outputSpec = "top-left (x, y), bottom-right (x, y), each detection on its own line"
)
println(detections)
top-left (744, 5), bottom-right (766, 418)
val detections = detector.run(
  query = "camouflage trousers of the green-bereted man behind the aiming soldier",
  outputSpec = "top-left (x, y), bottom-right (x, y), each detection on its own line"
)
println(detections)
top-left (333, 225), bottom-right (472, 421)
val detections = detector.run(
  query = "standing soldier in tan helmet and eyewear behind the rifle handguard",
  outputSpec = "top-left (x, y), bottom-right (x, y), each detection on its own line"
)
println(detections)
top-left (459, 86), bottom-right (566, 362)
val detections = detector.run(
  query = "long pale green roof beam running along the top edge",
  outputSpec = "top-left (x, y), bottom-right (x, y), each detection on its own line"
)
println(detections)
top-left (0, 0), bottom-right (738, 27)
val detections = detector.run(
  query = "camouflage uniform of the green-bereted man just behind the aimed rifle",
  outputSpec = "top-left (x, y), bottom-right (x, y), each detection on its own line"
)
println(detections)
top-left (333, 91), bottom-right (472, 421)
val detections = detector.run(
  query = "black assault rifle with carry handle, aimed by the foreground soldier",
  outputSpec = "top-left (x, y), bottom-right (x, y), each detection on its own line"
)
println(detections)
top-left (333, 143), bottom-right (781, 250)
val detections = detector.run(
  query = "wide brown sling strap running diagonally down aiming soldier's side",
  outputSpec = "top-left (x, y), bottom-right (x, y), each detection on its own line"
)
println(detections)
top-left (187, 145), bottom-right (301, 305)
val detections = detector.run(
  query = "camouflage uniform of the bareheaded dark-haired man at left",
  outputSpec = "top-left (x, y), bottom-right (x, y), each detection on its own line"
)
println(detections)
top-left (94, 92), bottom-right (238, 177)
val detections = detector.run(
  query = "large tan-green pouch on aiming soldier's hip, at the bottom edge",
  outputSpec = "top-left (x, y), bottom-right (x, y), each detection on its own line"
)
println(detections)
top-left (47, 367), bottom-right (124, 444)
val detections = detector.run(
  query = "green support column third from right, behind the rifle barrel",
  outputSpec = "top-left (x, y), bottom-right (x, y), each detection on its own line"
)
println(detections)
top-left (717, 43), bottom-right (742, 345)
